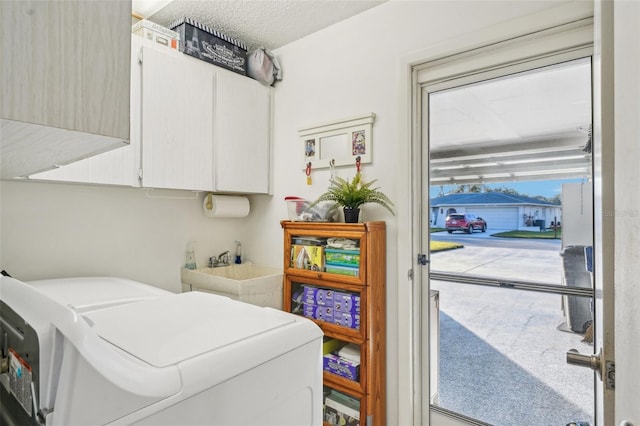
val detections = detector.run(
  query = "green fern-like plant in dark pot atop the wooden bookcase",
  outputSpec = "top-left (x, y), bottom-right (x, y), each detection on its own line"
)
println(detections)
top-left (310, 172), bottom-right (394, 223)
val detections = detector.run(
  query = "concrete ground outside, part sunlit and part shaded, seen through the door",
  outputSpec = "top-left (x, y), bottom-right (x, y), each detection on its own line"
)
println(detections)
top-left (431, 243), bottom-right (594, 426)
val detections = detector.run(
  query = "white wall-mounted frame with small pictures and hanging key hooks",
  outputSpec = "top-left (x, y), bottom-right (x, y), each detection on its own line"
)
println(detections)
top-left (298, 113), bottom-right (376, 169)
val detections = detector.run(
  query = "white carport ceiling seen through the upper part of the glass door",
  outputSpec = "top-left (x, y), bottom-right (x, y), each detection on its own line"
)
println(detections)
top-left (423, 58), bottom-right (592, 185)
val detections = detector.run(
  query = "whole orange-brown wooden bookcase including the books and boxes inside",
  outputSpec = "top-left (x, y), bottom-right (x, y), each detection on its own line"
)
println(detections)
top-left (281, 221), bottom-right (386, 426)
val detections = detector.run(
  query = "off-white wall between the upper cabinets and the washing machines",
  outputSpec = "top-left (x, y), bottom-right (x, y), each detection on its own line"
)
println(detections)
top-left (0, 181), bottom-right (252, 292)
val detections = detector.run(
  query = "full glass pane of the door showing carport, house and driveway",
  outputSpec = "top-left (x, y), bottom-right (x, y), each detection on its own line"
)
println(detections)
top-left (425, 58), bottom-right (594, 425)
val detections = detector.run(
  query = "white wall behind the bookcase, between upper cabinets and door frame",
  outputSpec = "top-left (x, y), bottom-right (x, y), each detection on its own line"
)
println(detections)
top-left (242, 0), bottom-right (572, 424)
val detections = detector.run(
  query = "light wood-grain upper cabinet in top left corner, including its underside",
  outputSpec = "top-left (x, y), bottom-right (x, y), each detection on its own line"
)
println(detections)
top-left (0, 0), bottom-right (131, 178)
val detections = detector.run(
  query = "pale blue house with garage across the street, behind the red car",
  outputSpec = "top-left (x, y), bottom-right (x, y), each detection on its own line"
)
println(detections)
top-left (431, 192), bottom-right (562, 231)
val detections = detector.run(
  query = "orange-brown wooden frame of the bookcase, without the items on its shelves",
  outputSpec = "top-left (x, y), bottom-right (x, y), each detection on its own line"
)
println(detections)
top-left (281, 221), bottom-right (386, 426)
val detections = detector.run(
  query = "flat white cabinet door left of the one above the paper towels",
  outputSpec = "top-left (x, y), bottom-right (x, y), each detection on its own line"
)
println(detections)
top-left (141, 47), bottom-right (214, 191)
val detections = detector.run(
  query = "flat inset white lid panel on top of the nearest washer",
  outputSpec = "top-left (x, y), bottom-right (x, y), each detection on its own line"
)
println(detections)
top-left (83, 292), bottom-right (295, 367)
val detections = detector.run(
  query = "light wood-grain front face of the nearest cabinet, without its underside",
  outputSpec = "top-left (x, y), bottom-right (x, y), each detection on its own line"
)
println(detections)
top-left (0, 0), bottom-right (131, 140)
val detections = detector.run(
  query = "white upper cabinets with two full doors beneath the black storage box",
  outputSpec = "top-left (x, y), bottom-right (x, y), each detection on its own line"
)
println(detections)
top-left (31, 36), bottom-right (272, 194)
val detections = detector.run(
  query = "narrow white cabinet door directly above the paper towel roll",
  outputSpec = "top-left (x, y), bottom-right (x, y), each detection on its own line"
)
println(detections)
top-left (214, 70), bottom-right (271, 194)
